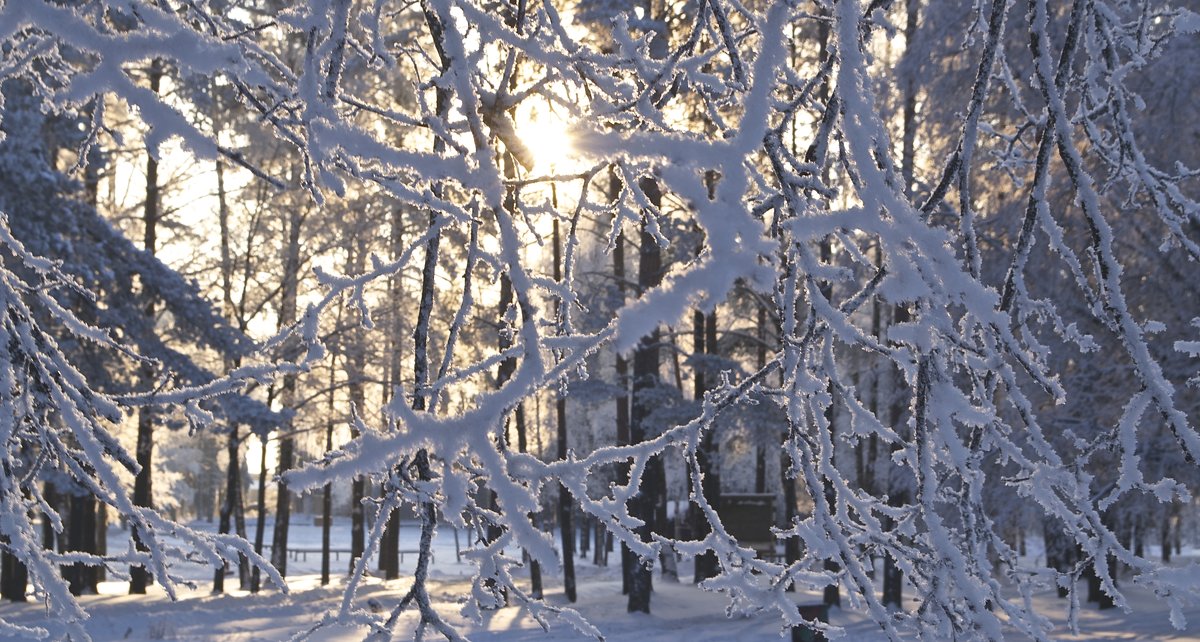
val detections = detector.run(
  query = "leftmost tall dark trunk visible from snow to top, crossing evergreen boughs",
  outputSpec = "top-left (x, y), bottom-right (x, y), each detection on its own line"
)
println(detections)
top-left (130, 58), bottom-right (163, 594)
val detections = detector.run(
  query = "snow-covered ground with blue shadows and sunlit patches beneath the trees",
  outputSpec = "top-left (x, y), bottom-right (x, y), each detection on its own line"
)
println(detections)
top-left (0, 516), bottom-right (1200, 642)
